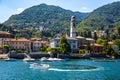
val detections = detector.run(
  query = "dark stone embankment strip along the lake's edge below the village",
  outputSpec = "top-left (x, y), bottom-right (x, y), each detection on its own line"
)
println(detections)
top-left (0, 53), bottom-right (120, 60)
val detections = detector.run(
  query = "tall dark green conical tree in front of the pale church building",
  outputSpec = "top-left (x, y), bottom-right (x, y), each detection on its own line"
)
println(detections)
top-left (59, 35), bottom-right (71, 53)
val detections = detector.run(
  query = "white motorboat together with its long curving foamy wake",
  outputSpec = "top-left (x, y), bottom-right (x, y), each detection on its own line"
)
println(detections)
top-left (30, 63), bottom-right (104, 72)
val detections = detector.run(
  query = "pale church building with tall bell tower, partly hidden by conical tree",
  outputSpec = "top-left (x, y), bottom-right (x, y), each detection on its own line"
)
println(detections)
top-left (50, 16), bottom-right (78, 52)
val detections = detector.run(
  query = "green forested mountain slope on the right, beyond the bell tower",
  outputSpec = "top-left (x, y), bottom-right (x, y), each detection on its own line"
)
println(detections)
top-left (79, 2), bottom-right (120, 29)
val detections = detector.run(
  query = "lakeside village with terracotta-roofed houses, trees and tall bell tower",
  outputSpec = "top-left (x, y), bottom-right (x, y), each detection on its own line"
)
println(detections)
top-left (0, 16), bottom-right (120, 59)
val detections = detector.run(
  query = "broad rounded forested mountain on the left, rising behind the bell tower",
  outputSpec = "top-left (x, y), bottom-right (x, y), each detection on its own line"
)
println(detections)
top-left (4, 4), bottom-right (88, 34)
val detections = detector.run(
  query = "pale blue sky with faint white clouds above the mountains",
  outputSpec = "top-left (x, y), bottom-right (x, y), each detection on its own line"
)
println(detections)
top-left (0, 0), bottom-right (120, 23)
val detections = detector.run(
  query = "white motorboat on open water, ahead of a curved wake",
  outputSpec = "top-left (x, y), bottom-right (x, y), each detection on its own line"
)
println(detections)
top-left (30, 63), bottom-right (50, 70)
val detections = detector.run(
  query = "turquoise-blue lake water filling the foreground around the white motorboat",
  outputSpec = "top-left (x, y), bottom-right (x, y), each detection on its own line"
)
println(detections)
top-left (0, 60), bottom-right (120, 80)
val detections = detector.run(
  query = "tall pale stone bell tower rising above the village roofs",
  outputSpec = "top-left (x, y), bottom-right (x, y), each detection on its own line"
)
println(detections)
top-left (70, 16), bottom-right (76, 38)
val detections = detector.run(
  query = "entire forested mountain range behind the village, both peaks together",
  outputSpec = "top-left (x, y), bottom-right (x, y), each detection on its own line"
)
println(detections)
top-left (4, 2), bottom-right (120, 38)
